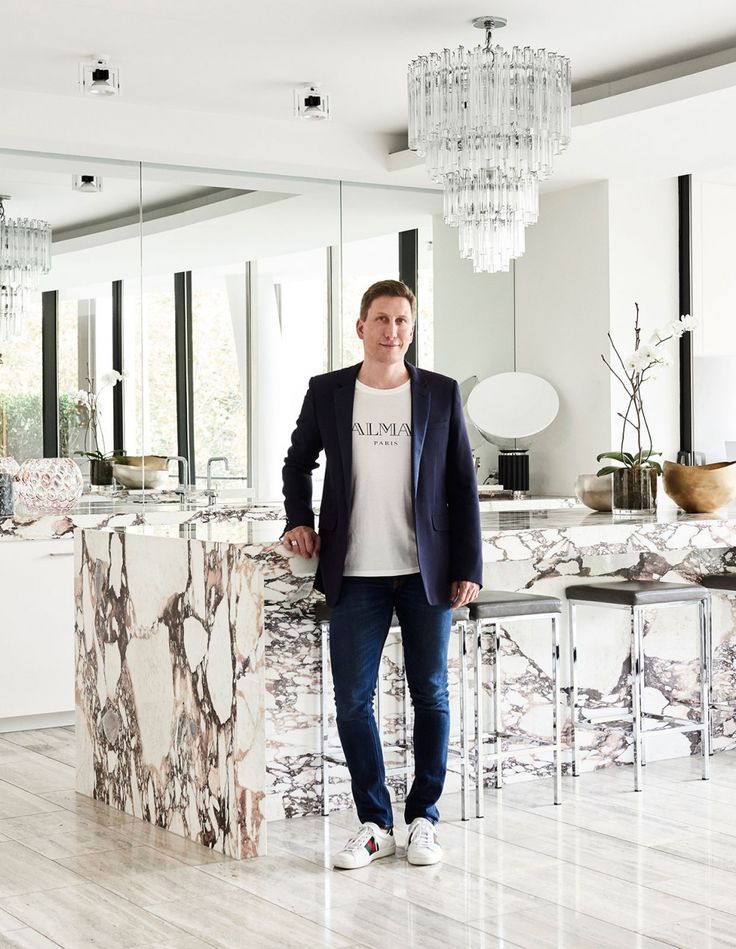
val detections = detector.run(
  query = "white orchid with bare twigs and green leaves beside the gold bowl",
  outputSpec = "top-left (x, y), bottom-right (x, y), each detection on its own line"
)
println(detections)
top-left (597, 303), bottom-right (697, 475)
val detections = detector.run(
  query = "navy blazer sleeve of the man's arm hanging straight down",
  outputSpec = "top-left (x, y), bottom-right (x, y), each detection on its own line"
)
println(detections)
top-left (446, 382), bottom-right (483, 586)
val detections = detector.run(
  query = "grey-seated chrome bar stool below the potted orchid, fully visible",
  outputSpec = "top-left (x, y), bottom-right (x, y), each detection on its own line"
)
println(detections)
top-left (566, 580), bottom-right (710, 791)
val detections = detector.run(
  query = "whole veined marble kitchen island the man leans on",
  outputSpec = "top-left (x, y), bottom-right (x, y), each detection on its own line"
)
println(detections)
top-left (75, 510), bottom-right (736, 857)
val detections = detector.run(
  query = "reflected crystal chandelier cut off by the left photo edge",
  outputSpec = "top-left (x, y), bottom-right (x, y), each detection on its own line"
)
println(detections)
top-left (0, 195), bottom-right (51, 343)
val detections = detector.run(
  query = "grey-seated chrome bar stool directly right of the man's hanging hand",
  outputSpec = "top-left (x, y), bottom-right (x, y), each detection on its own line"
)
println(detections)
top-left (461, 591), bottom-right (562, 818)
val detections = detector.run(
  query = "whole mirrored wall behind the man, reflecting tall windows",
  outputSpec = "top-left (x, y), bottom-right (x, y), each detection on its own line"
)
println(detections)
top-left (0, 153), bottom-right (513, 504)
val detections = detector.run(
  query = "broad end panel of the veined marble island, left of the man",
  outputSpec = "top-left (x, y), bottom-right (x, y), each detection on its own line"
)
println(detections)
top-left (76, 531), bottom-right (265, 857)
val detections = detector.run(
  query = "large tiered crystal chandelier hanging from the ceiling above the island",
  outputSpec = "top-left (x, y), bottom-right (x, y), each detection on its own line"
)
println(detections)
top-left (408, 16), bottom-right (571, 273)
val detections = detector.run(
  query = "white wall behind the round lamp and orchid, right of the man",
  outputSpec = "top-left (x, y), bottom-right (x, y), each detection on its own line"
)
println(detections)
top-left (435, 179), bottom-right (679, 495)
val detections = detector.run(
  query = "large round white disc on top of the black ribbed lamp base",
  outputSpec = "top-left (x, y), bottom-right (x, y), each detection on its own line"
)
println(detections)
top-left (467, 372), bottom-right (560, 448)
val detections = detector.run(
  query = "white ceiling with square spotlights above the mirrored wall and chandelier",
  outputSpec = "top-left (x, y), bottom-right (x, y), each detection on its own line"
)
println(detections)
top-left (0, 0), bottom-right (736, 186)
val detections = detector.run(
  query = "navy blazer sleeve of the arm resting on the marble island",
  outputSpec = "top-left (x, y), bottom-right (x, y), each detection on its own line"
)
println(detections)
top-left (281, 379), bottom-right (323, 531)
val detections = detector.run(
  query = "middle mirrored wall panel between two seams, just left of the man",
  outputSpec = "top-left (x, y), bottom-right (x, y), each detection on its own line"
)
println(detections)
top-left (139, 165), bottom-right (340, 501)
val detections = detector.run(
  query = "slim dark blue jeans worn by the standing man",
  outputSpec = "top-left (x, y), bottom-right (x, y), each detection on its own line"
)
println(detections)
top-left (330, 573), bottom-right (452, 827)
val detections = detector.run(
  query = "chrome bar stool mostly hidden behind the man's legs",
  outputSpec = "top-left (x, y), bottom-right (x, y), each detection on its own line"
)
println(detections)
top-left (314, 600), bottom-right (469, 820)
